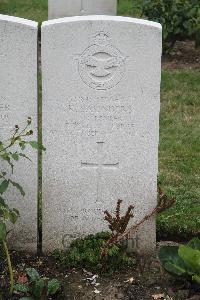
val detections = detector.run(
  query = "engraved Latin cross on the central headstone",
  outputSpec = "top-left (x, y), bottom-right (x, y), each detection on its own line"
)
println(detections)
top-left (81, 142), bottom-right (119, 201)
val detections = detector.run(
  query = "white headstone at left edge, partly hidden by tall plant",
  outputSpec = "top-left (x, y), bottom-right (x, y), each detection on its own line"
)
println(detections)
top-left (0, 15), bottom-right (37, 251)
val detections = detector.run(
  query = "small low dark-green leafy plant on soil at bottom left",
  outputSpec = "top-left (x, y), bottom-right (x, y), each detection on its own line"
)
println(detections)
top-left (14, 268), bottom-right (60, 300)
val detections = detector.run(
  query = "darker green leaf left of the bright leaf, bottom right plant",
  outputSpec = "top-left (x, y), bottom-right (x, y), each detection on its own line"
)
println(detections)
top-left (158, 246), bottom-right (187, 276)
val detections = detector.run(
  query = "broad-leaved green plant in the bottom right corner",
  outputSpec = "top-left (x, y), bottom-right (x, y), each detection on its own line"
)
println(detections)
top-left (159, 238), bottom-right (200, 284)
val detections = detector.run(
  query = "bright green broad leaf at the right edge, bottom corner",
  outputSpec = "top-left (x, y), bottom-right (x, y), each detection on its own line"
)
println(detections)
top-left (178, 245), bottom-right (200, 274)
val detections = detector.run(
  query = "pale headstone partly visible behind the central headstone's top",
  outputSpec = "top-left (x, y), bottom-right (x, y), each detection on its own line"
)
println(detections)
top-left (48, 0), bottom-right (117, 19)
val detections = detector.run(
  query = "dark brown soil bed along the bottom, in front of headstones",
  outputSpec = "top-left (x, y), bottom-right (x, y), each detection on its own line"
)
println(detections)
top-left (0, 242), bottom-right (200, 300)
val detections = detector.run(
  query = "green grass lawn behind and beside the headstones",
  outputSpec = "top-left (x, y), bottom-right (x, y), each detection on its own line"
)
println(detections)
top-left (0, 0), bottom-right (200, 238)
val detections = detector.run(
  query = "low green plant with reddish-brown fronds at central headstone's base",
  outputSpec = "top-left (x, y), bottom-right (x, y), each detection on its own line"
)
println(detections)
top-left (53, 189), bottom-right (175, 274)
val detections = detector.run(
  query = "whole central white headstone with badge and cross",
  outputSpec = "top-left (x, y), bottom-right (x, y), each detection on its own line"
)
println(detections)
top-left (42, 16), bottom-right (162, 251)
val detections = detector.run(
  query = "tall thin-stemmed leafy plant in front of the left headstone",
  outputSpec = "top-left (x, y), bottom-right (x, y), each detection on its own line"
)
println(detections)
top-left (0, 117), bottom-right (44, 295)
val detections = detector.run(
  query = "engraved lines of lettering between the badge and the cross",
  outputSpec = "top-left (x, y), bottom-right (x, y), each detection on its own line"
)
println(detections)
top-left (63, 95), bottom-right (135, 137)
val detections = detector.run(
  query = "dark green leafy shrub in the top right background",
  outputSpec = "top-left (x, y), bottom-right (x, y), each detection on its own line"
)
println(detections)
top-left (143, 0), bottom-right (200, 50)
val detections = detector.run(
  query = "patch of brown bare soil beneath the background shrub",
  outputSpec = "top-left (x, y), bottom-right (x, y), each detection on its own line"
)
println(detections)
top-left (162, 41), bottom-right (200, 70)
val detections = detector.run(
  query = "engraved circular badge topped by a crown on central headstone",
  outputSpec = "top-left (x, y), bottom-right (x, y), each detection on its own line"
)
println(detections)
top-left (79, 32), bottom-right (125, 90)
